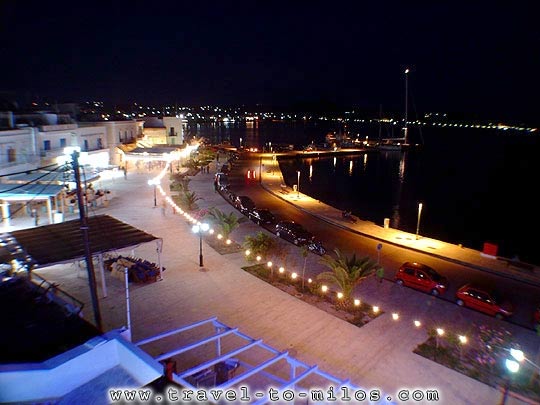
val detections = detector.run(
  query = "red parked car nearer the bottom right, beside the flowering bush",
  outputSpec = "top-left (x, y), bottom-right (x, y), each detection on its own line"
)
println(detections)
top-left (456, 284), bottom-right (514, 319)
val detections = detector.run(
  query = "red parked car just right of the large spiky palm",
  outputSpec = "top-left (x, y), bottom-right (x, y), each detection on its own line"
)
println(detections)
top-left (395, 262), bottom-right (448, 295)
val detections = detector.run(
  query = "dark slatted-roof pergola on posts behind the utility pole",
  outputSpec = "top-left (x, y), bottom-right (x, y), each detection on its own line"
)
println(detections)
top-left (0, 215), bottom-right (163, 297)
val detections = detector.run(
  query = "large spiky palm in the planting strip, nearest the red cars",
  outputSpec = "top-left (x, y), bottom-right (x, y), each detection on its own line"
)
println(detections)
top-left (317, 249), bottom-right (380, 309)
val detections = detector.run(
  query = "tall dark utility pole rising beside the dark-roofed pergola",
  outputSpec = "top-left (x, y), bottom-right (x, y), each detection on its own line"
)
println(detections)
top-left (71, 151), bottom-right (103, 332)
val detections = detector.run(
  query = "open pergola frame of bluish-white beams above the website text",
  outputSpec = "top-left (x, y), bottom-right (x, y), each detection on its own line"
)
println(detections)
top-left (135, 317), bottom-right (395, 405)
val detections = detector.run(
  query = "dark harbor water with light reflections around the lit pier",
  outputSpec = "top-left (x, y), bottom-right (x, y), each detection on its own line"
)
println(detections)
top-left (187, 122), bottom-right (540, 265)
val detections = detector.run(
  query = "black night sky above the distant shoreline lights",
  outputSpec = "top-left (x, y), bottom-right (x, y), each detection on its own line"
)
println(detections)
top-left (0, 0), bottom-right (540, 122)
